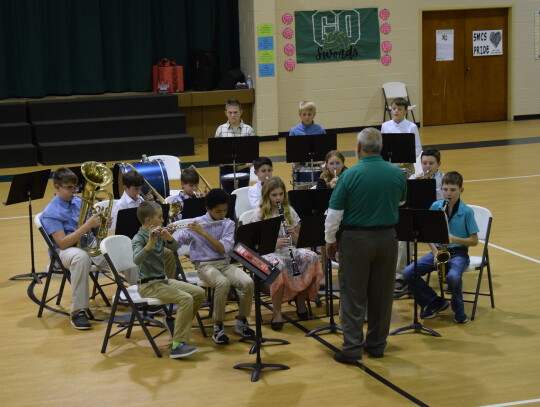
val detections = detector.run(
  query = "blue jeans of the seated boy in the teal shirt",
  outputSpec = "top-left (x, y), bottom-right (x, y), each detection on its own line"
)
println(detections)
top-left (403, 253), bottom-right (470, 312)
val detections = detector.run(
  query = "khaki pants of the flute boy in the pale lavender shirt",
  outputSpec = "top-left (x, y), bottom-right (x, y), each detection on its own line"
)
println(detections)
top-left (197, 259), bottom-right (254, 321)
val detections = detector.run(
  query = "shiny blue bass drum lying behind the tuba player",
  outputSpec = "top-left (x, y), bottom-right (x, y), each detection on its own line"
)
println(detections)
top-left (113, 160), bottom-right (170, 199)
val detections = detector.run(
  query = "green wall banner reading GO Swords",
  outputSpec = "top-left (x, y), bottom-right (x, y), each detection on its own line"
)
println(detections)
top-left (294, 8), bottom-right (381, 63)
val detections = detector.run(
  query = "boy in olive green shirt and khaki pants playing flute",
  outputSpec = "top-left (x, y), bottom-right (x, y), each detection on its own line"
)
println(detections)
top-left (132, 202), bottom-right (205, 359)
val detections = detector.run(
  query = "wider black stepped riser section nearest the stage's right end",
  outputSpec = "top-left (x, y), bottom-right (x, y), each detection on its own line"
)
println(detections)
top-left (27, 94), bottom-right (194, 165)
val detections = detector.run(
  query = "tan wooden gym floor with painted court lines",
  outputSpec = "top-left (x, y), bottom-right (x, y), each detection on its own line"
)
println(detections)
top-left (0, 121), bottom-right (540, 406)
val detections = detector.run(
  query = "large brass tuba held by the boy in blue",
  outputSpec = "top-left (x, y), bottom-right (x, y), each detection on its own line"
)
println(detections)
top-left (77, 161), bottom-right (114, 256)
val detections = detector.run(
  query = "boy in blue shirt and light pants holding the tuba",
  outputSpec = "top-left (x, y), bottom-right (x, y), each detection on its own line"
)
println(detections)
top-left (41, 167), bottom-right (137, 329)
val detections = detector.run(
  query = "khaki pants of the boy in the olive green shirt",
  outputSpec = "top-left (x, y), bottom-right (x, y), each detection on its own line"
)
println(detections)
top-left (137, 280), bottom-right (205, 342)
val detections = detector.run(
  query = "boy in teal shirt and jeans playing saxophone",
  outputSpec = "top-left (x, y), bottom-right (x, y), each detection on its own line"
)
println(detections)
top-left (403, 171), bottom-right (479, 324)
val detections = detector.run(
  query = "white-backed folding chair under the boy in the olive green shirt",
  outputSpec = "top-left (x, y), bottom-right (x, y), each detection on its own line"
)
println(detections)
top-left (100, 235), bottom-right (172, 357)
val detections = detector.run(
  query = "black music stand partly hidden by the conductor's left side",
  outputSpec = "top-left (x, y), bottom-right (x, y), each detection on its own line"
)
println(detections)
top-left (296, 215), bottom-right (343, 336)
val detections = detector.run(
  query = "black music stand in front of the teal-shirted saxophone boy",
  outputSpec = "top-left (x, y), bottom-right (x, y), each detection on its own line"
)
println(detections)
top-left (389, 209), bottom-right (450, 337)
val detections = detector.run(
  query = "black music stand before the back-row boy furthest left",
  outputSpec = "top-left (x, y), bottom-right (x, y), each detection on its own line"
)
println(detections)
top-left (208, 136), bottom-right (259, 189)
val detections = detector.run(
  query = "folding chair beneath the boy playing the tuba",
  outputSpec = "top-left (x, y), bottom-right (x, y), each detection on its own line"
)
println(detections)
top-left (34, 213), bottom-right (111, 319)
